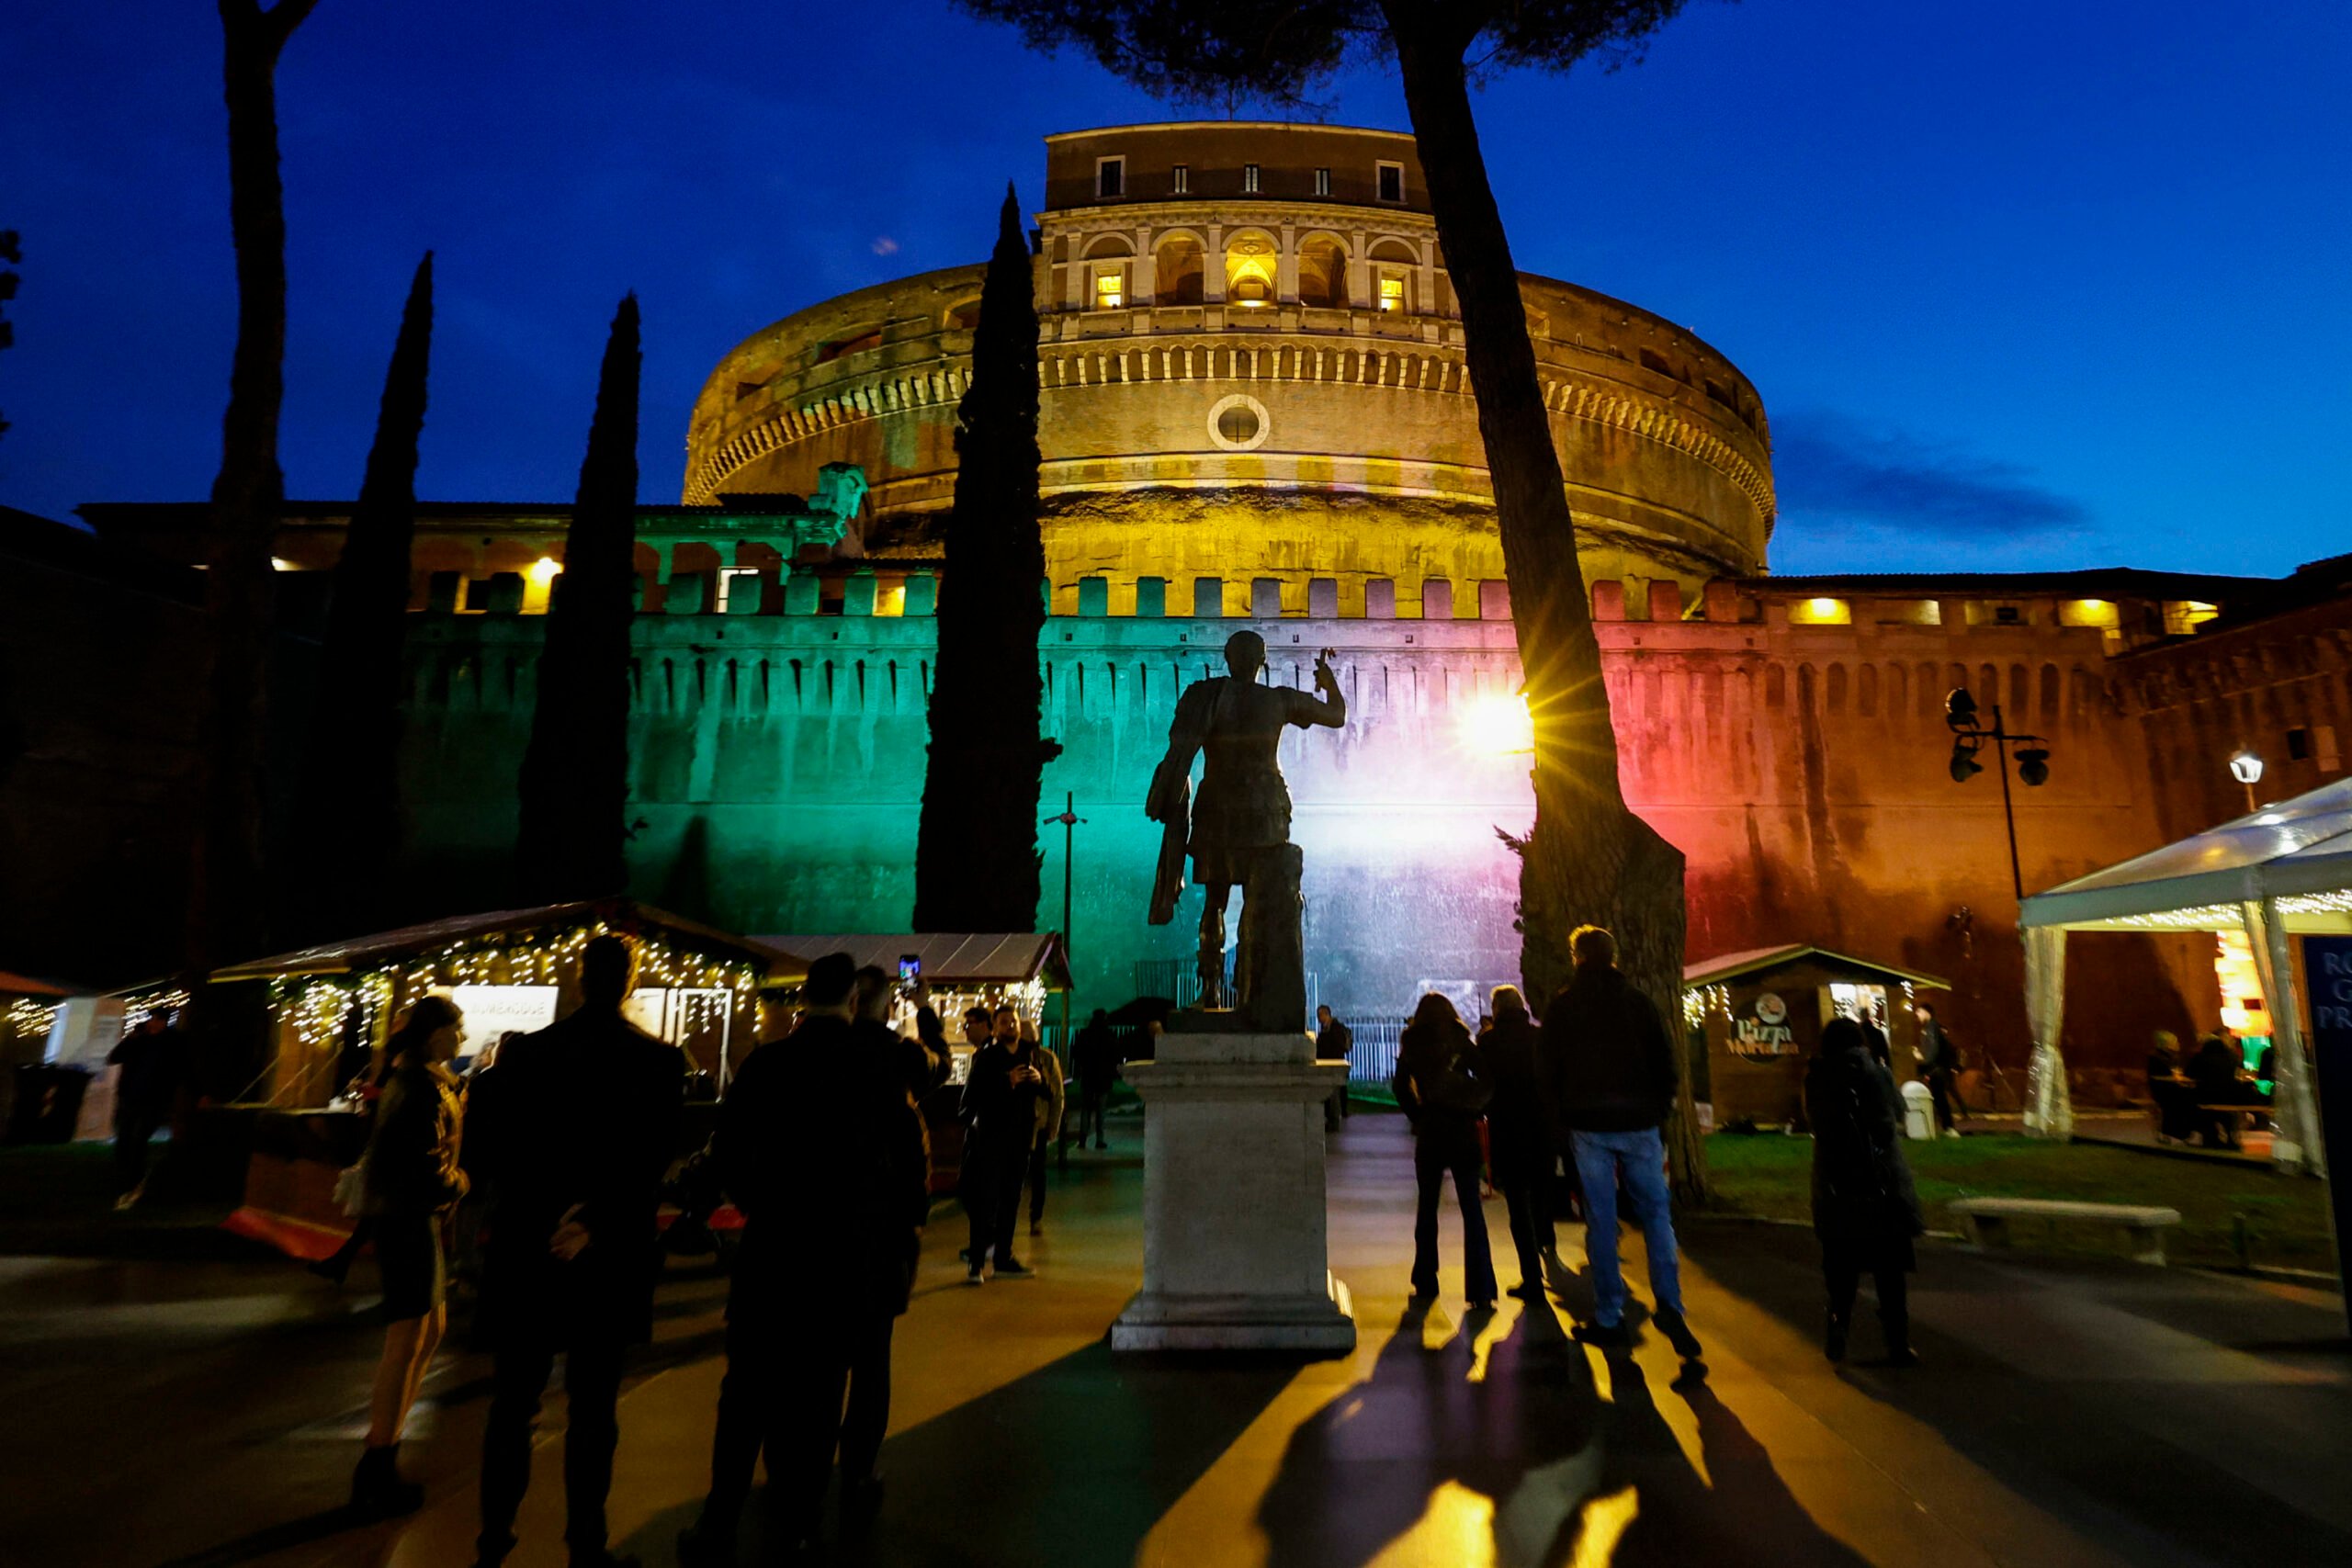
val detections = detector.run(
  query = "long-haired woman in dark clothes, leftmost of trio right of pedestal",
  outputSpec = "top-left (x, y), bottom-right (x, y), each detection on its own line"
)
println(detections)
top-left (1393, 992), bottom-right (1494, 1307)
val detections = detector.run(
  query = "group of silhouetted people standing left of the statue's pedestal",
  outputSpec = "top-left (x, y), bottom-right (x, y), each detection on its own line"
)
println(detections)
top-left (300, 936), bottom-right (1120, 1568)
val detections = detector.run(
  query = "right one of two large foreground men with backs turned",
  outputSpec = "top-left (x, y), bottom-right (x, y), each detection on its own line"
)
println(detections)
top-left (677, 952), bottom-right (932, 1568)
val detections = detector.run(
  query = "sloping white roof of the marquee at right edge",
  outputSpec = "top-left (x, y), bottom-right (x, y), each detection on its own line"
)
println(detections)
top-left (2018, 778), bottom-right (2352, 931)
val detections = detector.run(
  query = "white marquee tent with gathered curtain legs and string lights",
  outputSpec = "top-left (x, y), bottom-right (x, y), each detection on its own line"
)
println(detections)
top-left (2018, 781), bottom-right (2352, 1176)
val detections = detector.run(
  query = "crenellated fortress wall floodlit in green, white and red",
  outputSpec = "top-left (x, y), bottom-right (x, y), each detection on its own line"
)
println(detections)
top-left (404, 576), bottom-right (2211, 1081)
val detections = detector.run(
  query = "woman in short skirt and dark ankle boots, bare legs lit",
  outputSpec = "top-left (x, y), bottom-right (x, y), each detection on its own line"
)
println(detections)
top-left (350, 997), bottom-right (466, 1517)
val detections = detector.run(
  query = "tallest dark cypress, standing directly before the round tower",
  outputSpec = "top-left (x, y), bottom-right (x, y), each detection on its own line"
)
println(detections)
top-left (915, 186), bottom-right (1061, 931)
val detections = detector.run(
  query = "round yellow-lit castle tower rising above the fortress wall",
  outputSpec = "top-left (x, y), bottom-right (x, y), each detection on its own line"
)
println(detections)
top-left (684, 120), bottom-right (1773, 616)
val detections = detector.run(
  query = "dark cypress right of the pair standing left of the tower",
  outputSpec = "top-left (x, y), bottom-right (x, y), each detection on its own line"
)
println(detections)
top-left (515, 294), bottom-right (642, 903)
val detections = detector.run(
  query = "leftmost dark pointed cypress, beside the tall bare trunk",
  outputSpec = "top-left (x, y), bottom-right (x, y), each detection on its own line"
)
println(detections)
top-left (289, 252), bottom-right (433, 942)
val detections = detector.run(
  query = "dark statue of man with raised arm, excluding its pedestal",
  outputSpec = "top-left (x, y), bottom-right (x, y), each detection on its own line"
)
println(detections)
top-left (1143, 632), bottom-right (1348, 1030)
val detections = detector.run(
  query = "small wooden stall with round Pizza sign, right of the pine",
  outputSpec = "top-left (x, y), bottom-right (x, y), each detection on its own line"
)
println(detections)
top-left (1681, 945), bottom-right (1950, 1126)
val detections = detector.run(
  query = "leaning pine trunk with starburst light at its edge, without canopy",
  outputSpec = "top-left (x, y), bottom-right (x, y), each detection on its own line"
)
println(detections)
top-left (1390, 5), bottom-right (1708, 1203)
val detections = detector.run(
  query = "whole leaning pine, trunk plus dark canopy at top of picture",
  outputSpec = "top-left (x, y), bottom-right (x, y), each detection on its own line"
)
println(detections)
top-left (955, 0), bottom-right (1705, 1201)
